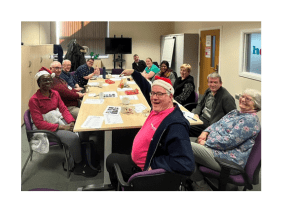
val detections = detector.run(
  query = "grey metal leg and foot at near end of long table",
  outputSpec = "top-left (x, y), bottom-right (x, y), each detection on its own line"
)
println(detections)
top-left (77, 131), bottom-right (113, 191)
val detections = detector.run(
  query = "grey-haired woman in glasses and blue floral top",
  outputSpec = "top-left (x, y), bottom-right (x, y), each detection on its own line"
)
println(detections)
top-left (191, 89), bottom-right (261, 190)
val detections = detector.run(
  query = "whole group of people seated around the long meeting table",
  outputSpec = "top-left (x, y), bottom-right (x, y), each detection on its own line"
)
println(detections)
top-left (29, 55), bottom-right (261, 190)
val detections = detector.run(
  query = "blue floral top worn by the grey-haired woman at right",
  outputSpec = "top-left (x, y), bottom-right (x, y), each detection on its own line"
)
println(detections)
top-left (204, 110), bottom-right (260, 168)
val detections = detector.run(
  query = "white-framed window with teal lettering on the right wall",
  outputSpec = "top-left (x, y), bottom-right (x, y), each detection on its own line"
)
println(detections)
top-left (239, 29), bottom-right (261, 81)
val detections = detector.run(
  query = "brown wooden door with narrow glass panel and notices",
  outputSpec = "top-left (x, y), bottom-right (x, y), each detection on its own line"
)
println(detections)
top-left (199, 29), bottom-right (220, 95)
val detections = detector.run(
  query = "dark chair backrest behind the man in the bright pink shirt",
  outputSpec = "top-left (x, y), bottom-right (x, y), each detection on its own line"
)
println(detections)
top-left (125, 169), bottom-right (186, 191)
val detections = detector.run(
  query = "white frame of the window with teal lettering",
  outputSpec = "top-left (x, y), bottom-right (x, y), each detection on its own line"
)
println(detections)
top-left (239, 28), bottom-right (261, 81)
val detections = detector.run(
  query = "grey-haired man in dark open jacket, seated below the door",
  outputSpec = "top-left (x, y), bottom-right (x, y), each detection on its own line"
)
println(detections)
top-left (189, 72), bottom-right (236, 137)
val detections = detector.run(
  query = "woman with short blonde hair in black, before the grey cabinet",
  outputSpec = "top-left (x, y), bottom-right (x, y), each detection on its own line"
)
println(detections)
top-left (173, 64), bottom-right (195, 105)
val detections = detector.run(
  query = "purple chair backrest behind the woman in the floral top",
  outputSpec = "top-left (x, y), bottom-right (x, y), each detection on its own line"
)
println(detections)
top-left (245, 131), bottom-right (261, 185)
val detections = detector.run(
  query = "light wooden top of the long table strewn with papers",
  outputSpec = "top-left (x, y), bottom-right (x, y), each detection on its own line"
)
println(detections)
top-left (73, 78), bottom-right (202, 132)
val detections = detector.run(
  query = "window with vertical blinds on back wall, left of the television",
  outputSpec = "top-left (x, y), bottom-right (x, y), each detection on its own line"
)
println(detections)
top-left (57, 21), bottom-right (109, 58)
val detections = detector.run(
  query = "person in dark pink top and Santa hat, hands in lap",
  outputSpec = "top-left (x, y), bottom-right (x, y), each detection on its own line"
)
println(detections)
top-left (28, 69), bottom-right (96, 176)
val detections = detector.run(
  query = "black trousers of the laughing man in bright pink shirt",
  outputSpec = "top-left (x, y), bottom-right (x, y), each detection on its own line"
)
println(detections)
top-left (106, 153), bottom-right (142, 190)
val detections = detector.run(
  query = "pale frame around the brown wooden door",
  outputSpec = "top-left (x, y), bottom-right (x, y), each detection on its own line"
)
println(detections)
top-left (196, 26), bottom-right (222, 93)
